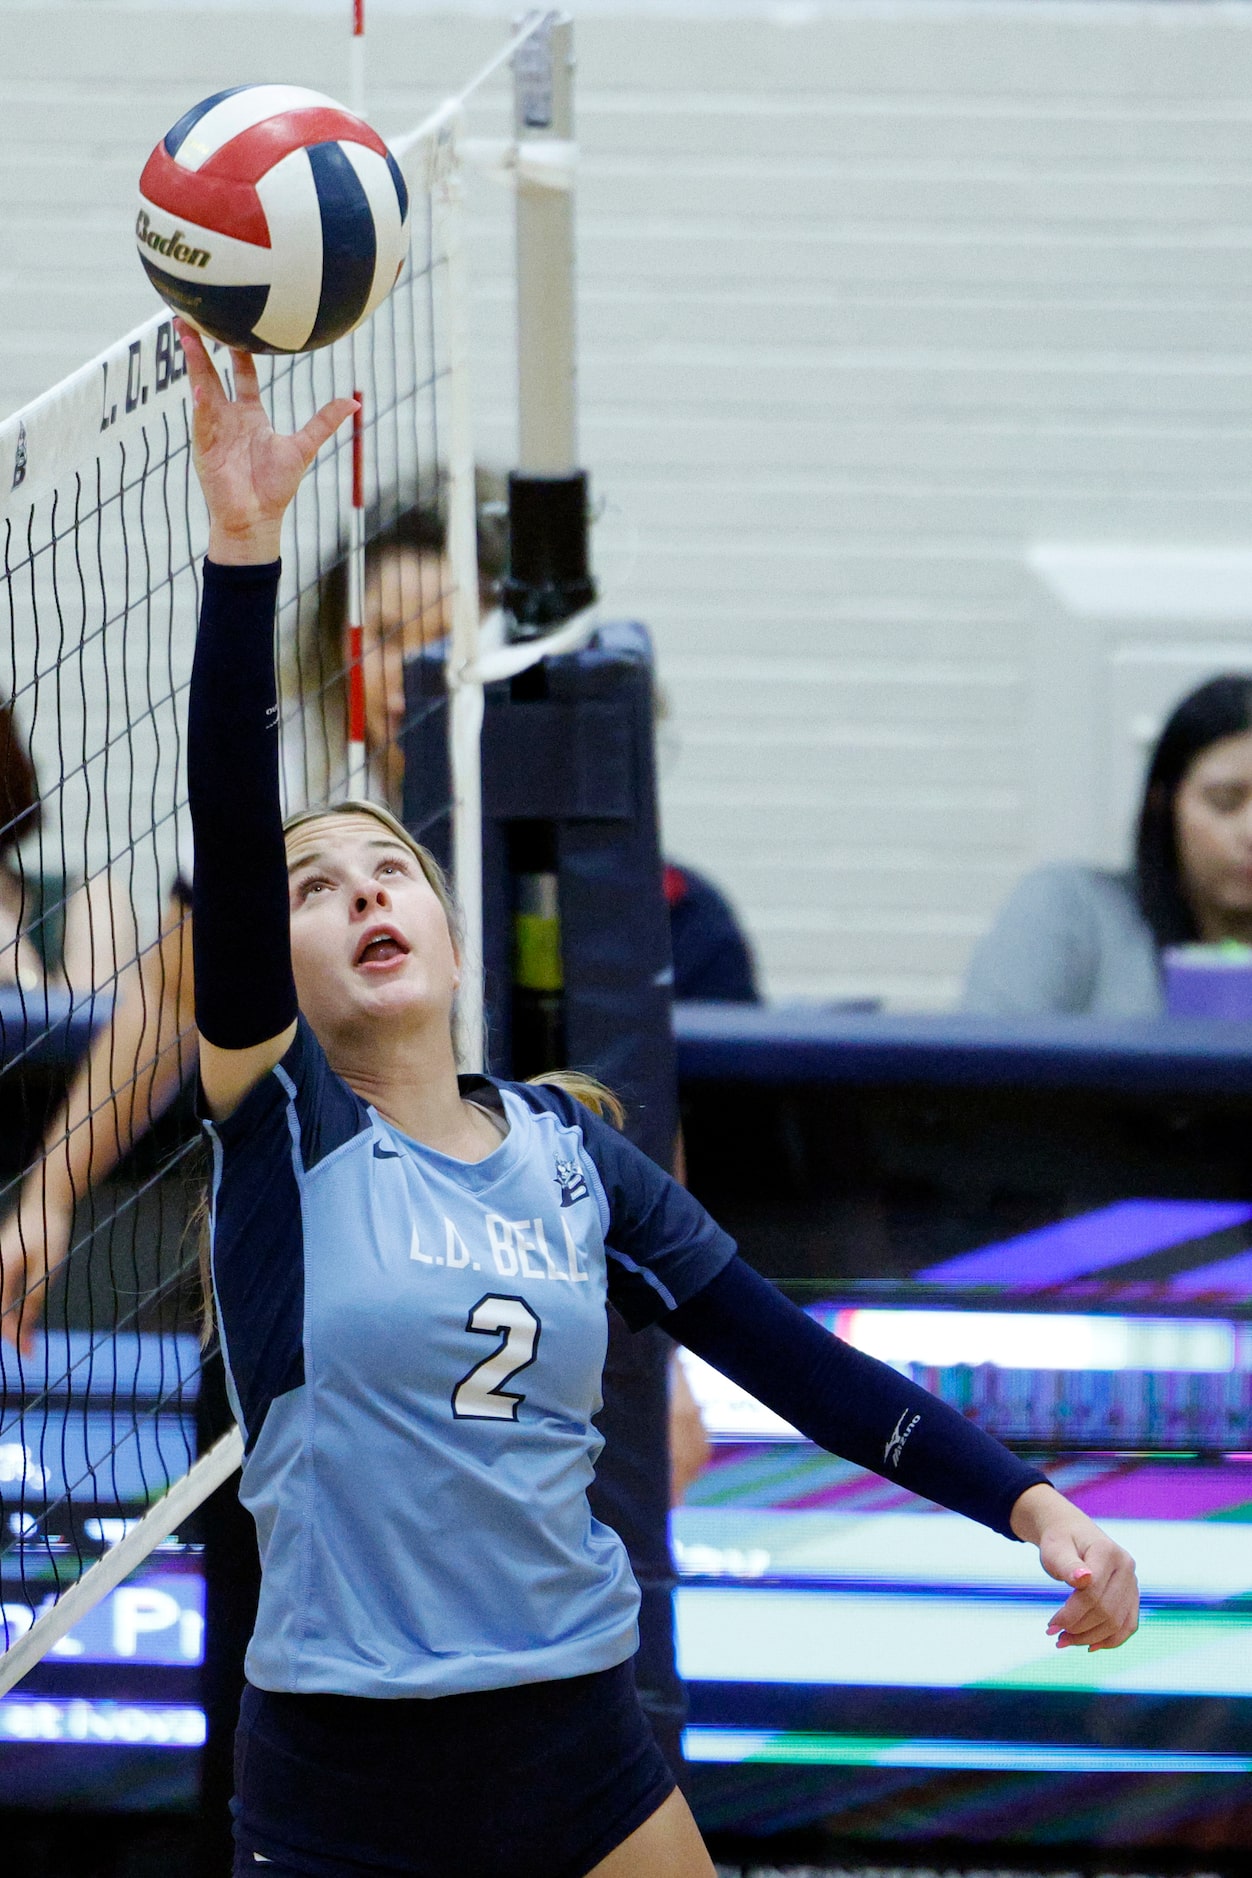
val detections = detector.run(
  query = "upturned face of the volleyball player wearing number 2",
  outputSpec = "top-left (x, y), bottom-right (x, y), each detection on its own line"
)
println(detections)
top-left (287, 815), bottom-right (460, 1050)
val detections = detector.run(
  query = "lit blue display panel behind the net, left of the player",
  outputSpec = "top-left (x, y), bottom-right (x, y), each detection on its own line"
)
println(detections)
top-left (0, 1332), bottom-right (205, 1810)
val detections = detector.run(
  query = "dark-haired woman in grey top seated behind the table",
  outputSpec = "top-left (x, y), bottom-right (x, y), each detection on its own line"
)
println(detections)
top-left (961, 672), bottom-right (1252, 1018)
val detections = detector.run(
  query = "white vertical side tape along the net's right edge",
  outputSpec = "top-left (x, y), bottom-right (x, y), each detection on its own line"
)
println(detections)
top-left (434, 118), bottom-right (486, 1070)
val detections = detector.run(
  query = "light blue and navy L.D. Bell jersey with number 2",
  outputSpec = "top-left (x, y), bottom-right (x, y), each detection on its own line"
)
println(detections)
top-left (208, 1020), bottom-right (734, 1696)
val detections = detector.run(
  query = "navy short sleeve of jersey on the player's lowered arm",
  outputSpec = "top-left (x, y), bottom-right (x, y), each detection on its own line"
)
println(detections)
top-left (505, 1082), bottom-right (736, 1330)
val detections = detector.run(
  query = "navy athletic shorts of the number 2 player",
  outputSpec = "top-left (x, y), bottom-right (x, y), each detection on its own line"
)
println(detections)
top-left (225, 1662), bottom-right (674, 1878)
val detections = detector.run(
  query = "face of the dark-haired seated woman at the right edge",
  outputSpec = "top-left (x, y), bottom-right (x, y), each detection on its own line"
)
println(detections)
top-left (1173, 731), bottom-right (1252, 937)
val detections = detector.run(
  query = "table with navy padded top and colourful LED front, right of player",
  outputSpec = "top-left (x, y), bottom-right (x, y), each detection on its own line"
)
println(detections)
top-left (672, 1007), bottom-right (1252, 1848)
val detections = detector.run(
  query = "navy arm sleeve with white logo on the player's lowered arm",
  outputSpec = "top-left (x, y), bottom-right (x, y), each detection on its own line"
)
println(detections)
top-left (661, 1258), bottom-right (1047, 1538)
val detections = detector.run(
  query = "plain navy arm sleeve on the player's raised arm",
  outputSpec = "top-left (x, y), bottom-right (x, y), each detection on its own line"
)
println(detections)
top-left (188, 562), bottom-right (297, 1050)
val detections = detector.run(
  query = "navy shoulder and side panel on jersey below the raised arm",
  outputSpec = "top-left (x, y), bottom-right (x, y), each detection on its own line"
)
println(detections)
top-left (208, 1018), bottom-right (370, 1448)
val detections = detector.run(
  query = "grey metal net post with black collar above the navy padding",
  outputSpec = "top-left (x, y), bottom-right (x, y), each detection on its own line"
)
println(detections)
top-left (501, 13), bottom-right (595, 640)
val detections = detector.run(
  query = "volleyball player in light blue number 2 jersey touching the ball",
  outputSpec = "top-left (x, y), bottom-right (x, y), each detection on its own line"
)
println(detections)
top-left (184, 332), bottom-right (1136, 1878)
